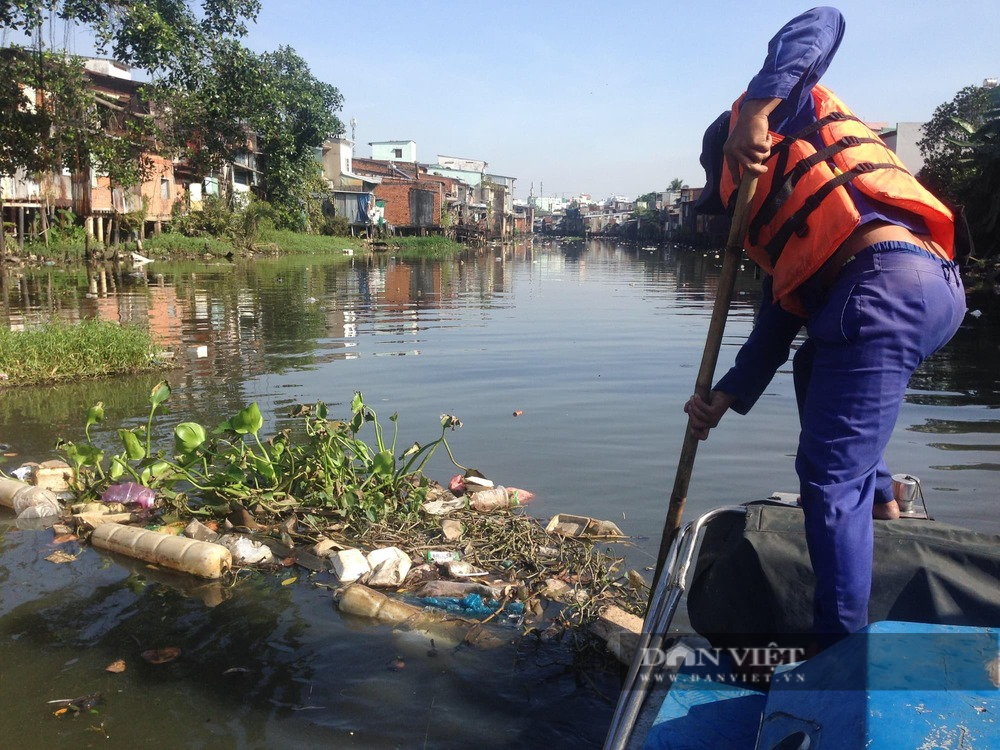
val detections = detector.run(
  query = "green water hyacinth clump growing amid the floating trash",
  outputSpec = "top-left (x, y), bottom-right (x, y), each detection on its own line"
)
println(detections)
top-left (58, 382), bottom-right (465, 521)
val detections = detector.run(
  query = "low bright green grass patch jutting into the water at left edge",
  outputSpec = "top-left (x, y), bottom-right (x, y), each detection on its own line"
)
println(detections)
top-left (0, 320), bottom-right (169, 386)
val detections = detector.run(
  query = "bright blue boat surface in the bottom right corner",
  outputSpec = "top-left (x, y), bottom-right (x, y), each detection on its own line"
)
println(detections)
top-left (644, 621), bottom-right (1000, 750)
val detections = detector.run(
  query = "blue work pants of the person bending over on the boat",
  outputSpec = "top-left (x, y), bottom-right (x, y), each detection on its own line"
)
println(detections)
top-left (794, 242), bottom-right (966, 645)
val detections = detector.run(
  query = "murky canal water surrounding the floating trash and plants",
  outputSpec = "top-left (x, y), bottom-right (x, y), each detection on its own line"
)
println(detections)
top-left (0, 238), bottom-right (1000, 750)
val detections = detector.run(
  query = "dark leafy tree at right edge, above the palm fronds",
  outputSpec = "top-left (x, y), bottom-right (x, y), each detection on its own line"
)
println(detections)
top-left (917, 86), bottom-right (994, 202)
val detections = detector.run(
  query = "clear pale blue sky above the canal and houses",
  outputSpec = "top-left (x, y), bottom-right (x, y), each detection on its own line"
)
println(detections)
top-left (23, 0), bottom-right (1000, 203)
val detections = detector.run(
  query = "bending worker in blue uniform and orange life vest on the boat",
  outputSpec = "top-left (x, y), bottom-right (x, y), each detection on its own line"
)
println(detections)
top-left (684, 7), bottom-right (965, 647)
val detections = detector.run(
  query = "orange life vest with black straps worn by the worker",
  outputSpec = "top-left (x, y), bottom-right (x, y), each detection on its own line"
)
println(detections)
top-left (720, 85), bottom-right (954, 315)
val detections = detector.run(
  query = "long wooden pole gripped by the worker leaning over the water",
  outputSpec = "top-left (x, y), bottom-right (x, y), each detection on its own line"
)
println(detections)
top-left (650, 172), bottom-right (757, 595)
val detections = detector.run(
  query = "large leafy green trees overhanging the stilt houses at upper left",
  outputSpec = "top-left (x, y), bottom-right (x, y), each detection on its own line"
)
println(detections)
top-left (0, 0), bottom-right (344, 236)
